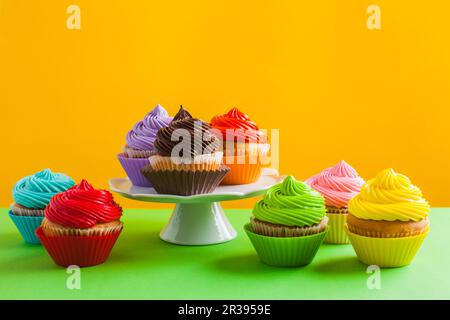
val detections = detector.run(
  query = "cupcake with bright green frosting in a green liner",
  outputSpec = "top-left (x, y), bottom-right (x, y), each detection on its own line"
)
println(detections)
top-left (244, 176), bottom-right (328, 267)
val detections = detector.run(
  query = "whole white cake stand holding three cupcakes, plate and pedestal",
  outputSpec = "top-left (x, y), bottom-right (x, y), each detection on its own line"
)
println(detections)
top-left (109, 168), bottom-right (282, 245)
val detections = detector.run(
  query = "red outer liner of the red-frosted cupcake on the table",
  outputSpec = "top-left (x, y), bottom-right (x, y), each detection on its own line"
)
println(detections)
top-left (36, 227), bottom-right (122, 267)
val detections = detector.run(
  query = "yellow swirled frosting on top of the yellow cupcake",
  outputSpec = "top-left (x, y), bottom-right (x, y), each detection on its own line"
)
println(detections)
top-left (349, 169), bottom-right (430, 221)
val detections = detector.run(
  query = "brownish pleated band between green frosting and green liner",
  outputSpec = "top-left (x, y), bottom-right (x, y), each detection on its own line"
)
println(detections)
top-left (250, 217), bottom-right (328, 237)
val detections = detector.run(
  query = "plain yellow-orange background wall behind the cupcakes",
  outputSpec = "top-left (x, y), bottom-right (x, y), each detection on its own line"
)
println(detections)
top-left (0, 0), bottom-right (450, 207)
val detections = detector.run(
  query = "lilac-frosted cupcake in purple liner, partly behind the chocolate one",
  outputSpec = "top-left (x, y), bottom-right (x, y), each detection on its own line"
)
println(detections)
top-left (117, 104), bottom-right (172, 187)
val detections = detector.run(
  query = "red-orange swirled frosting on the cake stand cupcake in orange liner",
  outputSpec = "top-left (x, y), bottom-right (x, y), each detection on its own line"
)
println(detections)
top-left (211, 108), bottom-right (267, 142)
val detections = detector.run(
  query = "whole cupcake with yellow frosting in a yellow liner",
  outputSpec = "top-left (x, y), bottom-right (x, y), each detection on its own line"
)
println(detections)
top-left (346, 169), bottom-right (430, 267)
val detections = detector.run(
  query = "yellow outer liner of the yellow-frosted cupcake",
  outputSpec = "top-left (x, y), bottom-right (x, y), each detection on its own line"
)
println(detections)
top-left (345, 226), bottom-right (429, 268)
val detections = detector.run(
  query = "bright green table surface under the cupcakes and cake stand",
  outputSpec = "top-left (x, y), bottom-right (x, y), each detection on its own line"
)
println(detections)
top-left (0, 208), bottom-right (450, 299)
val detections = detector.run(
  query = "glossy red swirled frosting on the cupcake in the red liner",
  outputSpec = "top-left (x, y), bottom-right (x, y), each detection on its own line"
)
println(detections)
top-left (45, 180), bottom-right (122, 229)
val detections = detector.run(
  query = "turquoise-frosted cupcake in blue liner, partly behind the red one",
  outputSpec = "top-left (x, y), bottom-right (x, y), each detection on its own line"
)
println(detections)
top-left (9, 169), bottom-right (75, 244)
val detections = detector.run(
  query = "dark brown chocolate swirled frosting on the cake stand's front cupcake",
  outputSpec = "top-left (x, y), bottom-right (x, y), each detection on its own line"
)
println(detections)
top-left (154, 106), bottom-right (219, 158)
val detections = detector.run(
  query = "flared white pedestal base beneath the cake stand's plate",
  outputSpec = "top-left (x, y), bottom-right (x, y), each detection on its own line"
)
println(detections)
top-left (160, 202), bottom-right (236, 245)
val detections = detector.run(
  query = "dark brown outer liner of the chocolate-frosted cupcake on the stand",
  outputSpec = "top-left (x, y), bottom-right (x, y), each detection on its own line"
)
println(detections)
top-left (142, 165), bottom-right (230, 196)
